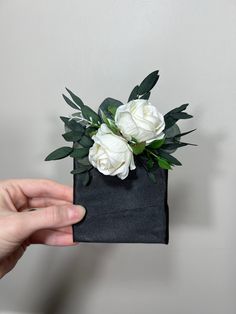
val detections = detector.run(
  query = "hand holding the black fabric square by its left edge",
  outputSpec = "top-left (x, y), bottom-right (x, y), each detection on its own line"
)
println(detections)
top-left (0, 179), bottom-right (85, 278)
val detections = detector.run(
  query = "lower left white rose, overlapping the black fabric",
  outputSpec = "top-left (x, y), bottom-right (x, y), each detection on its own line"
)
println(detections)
top-left (88, 123), bottom-right (136, 180)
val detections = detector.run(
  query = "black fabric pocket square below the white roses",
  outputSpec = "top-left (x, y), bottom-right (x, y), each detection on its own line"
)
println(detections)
top-left (73, 159), bottom-right (169, 244)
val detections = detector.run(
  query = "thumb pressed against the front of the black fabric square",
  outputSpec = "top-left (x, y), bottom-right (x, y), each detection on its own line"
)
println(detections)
top-left (12, 205), bottom-right (86, 241)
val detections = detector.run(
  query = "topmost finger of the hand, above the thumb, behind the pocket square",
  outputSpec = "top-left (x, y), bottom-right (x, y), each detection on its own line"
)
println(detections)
top-left (6, 179), bottom-right (73, 202)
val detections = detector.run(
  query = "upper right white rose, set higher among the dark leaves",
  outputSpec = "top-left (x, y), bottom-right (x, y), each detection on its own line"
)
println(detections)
top-left (115, 99), bottom-right (165, 143)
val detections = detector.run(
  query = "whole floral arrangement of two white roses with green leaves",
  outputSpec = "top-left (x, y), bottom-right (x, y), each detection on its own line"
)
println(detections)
top-left (45, 71), bottom-right (195, 185)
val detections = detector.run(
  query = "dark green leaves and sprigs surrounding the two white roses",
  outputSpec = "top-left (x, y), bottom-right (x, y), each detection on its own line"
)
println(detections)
top-left (45, 71), bottom-right (196, 185)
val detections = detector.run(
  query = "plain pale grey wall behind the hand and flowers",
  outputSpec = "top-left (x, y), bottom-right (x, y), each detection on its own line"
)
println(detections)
top-left (0, 0), bottom-right (236, 314)
